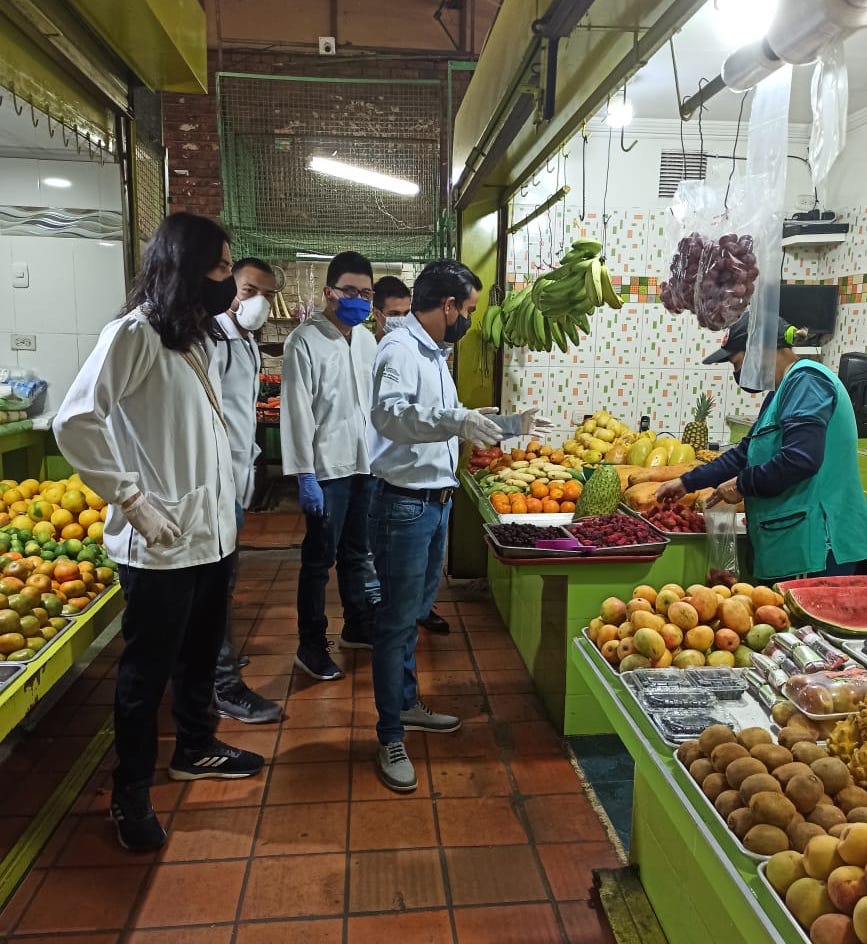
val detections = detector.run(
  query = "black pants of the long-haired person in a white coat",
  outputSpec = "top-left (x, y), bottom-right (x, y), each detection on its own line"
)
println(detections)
top-left (114, 557), bottom-right (232, 787)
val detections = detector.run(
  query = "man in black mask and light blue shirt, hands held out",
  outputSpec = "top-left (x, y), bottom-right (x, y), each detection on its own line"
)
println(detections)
top-left (370, 260), bottom-right (550, 792)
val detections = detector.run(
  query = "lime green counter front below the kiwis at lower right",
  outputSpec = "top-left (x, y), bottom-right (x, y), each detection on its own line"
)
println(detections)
top-left (569, 637), bottom-right (803, 944)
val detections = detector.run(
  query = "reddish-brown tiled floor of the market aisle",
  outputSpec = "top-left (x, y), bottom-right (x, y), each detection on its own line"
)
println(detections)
top-left (0, 553), bottom-right (619, 944)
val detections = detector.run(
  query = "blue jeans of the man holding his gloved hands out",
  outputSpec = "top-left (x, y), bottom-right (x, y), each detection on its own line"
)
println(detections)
top-left (370, 486), bottom-right (451, 744)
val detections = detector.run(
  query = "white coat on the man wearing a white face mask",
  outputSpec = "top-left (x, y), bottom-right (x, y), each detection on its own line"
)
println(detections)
top-left (214, 313), bottom-right (262, 508)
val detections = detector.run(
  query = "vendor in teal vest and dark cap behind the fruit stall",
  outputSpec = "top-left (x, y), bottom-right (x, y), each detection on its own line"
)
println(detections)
top-left (656, 314), bottom-right (867, 581)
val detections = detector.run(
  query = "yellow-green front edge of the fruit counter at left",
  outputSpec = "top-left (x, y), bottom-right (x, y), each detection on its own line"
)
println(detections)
top-left (0, 583), bottom-right (124, 741)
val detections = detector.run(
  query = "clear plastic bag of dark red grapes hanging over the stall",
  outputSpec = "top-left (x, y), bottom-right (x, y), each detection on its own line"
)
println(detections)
top-left (660, 180), bottom-right (761, 331)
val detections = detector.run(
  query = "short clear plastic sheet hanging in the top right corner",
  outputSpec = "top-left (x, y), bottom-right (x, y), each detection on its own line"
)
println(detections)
top-left (810, 40), bottom-right (849, 206)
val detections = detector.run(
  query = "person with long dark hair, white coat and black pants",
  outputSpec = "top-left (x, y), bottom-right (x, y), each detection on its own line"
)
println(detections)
top-left (54, 213), bottom-right (264, 851)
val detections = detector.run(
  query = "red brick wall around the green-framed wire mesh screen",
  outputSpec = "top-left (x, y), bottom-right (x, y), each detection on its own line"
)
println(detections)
top-left (163, 50), bottom-right (471, 217)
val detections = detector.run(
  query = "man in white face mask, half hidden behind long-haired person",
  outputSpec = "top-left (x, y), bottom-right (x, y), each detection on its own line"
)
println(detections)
top-left (214, 258), bottom-right (283, 724)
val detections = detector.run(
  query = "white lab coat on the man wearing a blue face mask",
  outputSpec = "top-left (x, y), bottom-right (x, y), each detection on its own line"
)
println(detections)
top-left (280, 314), bottom-right (376, 482)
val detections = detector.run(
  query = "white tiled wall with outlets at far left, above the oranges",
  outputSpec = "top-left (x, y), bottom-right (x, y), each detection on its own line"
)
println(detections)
top-left (0, 159), bottom-right (126, 410)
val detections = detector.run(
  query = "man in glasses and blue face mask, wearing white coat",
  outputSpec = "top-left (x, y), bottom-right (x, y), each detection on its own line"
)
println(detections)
top-left (280, 252), bottom-right (376, 681)
